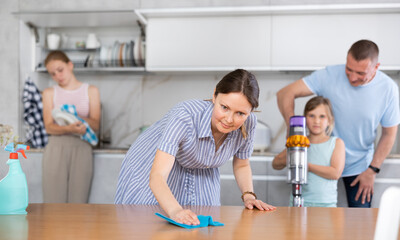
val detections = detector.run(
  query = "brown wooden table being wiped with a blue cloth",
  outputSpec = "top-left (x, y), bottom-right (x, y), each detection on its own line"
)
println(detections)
top-left (0, 204), bottom-right (390, 240)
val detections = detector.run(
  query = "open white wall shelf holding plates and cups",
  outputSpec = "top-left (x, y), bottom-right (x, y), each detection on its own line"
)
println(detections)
top-left (13, 10), bottom-right (145, 73)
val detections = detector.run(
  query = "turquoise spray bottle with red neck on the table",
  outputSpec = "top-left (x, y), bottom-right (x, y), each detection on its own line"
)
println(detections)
top-left (0, 143), bottom-right (29, 215)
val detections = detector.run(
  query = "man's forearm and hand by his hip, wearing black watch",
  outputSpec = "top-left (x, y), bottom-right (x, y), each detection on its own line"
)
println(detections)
top-left (350, 126), bottom-right (397, 204)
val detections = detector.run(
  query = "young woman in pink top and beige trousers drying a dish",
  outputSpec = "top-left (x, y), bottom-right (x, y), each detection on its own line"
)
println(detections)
top-left (43, 51), bottom-right (100, 203)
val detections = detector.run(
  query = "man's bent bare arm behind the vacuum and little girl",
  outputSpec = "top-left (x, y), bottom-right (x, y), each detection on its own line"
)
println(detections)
top-left (276, 79), bottom-right (313, 126)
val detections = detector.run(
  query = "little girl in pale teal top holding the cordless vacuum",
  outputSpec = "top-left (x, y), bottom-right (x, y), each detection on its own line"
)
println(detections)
top-left (272, 96), bottom-right (345, 207)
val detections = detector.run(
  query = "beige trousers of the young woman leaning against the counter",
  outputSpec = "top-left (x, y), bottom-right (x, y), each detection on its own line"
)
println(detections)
top-left (42, 135), bottom-right (93, 203)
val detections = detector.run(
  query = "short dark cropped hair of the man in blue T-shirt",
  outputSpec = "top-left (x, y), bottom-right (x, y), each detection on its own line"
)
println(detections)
top-left (348, 39), bottom-right (379, 62)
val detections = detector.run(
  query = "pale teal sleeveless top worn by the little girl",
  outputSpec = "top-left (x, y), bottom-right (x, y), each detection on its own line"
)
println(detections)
top-left (290, 137), bottom-right (338, 207)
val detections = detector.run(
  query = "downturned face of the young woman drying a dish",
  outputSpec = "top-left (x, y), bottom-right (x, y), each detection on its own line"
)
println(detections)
top-left (46, 60), bottom-right (73, 86)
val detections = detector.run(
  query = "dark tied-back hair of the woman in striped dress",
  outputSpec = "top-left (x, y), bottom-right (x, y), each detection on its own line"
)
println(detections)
top-left (214, 69), bottom-right (260, 110)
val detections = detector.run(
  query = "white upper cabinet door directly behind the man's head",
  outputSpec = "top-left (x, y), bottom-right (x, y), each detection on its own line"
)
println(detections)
top-left (271, 13), bottom-right (400, 69)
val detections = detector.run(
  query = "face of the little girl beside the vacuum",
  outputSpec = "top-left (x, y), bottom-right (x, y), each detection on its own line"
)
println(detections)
top-left (306, 104), bottom-right (330, 135)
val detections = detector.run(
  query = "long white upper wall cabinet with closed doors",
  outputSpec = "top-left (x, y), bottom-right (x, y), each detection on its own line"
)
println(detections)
top-left (139, 3), bottom-right (400, 72)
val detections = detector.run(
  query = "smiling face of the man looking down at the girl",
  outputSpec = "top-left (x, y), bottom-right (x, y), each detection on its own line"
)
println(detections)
top-left (346, 54), bottom-right (379, 87)
